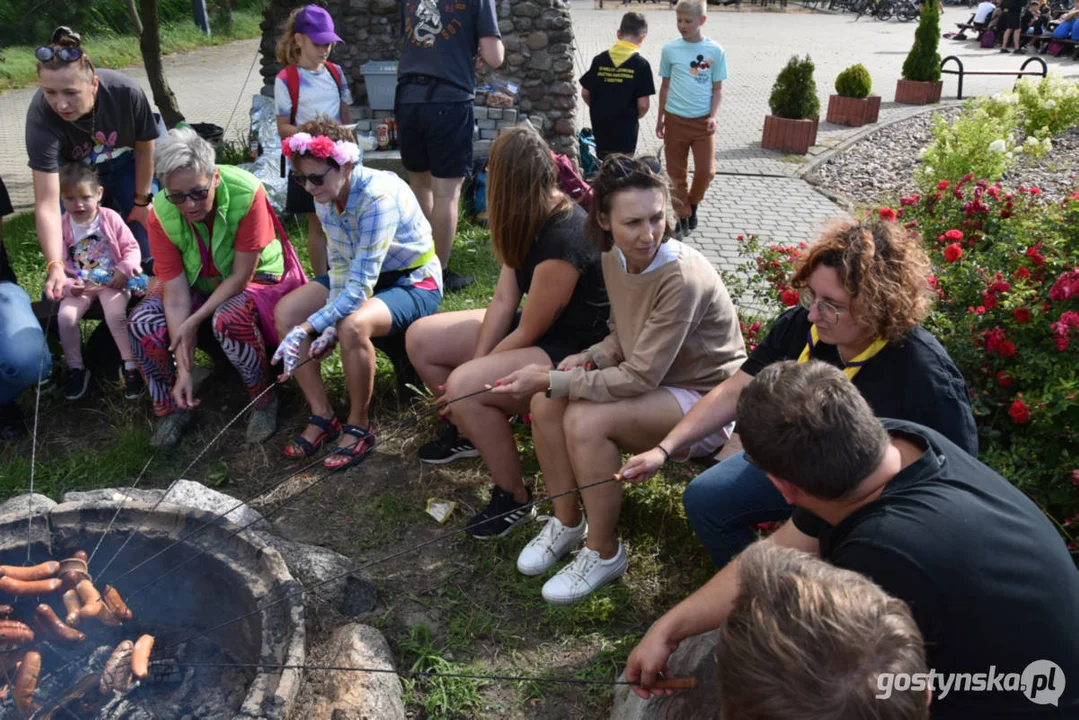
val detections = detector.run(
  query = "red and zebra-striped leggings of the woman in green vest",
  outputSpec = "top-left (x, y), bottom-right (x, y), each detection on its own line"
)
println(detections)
top-left (127, 290), bottom-right (273, 417)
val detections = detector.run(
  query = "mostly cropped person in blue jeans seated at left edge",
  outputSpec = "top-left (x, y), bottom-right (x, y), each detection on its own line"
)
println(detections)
top-left (0, 180), bottom-right (53, 441)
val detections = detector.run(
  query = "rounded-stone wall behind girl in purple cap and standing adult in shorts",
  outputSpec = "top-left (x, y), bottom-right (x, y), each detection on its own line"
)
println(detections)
top-left (261, 0), bottom-right (577, 159)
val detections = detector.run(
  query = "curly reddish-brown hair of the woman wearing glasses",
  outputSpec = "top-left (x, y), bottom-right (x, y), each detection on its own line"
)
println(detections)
top-left (791, 220), bottom-right (931, 342)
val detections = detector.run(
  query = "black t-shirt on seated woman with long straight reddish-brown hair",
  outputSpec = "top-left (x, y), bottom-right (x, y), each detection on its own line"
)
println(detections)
top-left (514, 205), bottom-right (611, 350)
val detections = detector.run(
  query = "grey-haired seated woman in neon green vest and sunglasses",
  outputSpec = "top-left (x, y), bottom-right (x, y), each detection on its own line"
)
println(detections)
top-left (129, 128), bottom-right (306, 448)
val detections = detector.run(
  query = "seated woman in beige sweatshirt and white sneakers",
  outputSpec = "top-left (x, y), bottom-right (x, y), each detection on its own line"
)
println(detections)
top-left (493, 155), bottom-right (746, 603)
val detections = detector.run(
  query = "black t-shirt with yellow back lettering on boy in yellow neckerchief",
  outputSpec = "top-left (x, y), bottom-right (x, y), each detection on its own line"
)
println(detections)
top-left (581, 51), bottom-right (656, 154)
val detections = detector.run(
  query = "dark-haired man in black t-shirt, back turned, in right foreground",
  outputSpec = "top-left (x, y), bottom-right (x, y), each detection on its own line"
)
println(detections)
top-left (626, 361), bottom-right (1079, 720)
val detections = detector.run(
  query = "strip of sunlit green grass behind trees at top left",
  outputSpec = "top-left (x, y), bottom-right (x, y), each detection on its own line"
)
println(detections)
top-left (0, 10), bottom-right (262, 92)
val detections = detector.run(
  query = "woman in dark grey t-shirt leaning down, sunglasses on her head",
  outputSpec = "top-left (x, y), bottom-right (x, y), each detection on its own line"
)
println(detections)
top-left (26, 27), bottom-right (159, 299)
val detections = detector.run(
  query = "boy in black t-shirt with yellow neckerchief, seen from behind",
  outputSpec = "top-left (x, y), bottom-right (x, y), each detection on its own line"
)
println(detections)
top-left (581, 13), bottom-right (656, 159)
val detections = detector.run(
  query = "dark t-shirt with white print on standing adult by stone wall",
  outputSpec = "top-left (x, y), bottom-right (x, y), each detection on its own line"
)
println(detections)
top-left (397, 0), bottom-right (502, 103)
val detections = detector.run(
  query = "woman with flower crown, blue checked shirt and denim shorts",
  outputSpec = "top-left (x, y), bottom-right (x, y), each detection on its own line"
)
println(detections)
top-left (273, 120), bottom-right (442, 468)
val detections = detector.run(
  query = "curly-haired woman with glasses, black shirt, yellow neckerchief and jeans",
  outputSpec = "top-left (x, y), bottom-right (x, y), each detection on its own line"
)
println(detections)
top-left (622, 216), bottom-right (978, 568)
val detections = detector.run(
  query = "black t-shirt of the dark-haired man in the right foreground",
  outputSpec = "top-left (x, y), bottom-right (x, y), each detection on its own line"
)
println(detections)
top-left (792, 420), bottom-right (1079, 720)
